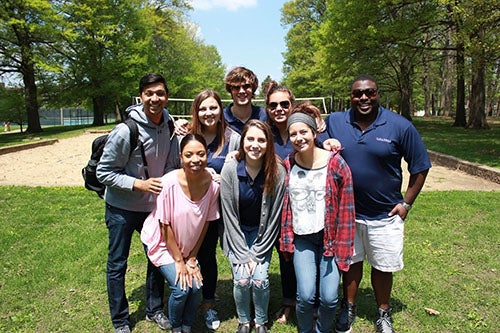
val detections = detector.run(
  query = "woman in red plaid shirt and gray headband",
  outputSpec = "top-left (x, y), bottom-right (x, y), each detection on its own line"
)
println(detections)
top-left (280, 103), bottom-right (355, 332)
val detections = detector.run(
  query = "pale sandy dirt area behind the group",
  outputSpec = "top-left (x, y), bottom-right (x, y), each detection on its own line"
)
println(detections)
top-left (0, 133), bottom-right (500, 191)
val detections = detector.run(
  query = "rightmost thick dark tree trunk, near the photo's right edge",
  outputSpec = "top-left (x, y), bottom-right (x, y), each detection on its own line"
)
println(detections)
top-left (467, 51), bottom-right (490, 129)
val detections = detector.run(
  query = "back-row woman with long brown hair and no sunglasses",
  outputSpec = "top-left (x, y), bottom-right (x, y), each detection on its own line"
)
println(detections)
top-left (189, 89), bottom-right (240, 331)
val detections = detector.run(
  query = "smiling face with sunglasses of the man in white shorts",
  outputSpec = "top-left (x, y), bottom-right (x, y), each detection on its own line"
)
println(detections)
top-left (351, 80), bottom-right (379, 118)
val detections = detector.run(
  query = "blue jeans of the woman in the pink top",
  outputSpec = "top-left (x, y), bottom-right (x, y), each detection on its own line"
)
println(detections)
top-left (160, 263), bottom-right (202, 329)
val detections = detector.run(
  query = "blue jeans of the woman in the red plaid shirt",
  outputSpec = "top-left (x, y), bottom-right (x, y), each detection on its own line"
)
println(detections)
top-left (293, 231), bottom-right (340, 333)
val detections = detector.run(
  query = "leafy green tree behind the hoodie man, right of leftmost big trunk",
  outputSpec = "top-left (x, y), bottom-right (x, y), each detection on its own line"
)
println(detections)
top-left (55, 0), bottom-right (151, 125)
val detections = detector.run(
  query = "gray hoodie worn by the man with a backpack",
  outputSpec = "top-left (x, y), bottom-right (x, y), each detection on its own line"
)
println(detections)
top-left (97, 104), bottom-right (180, 212)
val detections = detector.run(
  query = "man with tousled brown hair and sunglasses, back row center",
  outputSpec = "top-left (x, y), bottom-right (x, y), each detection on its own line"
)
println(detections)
top-left (224, 67), bottom-right (267, 134)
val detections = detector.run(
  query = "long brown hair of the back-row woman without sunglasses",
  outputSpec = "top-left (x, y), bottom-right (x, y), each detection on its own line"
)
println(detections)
top-left (191, 89), bottom-right (227, 156)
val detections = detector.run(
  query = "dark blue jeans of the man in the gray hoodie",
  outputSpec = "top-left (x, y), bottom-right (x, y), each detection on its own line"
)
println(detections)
top-left (105, 204), bottom-right (165, 328)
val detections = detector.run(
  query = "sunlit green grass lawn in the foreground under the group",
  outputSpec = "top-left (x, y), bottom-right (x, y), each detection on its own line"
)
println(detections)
top-left (0, 186), bottom-right (500, 333)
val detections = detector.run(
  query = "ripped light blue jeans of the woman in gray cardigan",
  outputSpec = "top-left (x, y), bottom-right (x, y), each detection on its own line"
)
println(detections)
top-left (229, 226), bottom-right (273, 325)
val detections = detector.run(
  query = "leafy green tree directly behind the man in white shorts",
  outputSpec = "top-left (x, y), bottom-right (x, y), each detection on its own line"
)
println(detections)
top-left (321, 0), bottom-right (436, 119)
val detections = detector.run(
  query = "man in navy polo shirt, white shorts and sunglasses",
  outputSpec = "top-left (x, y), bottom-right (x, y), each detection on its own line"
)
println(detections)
top-left (326, 75), bottom-right (431, 333)
